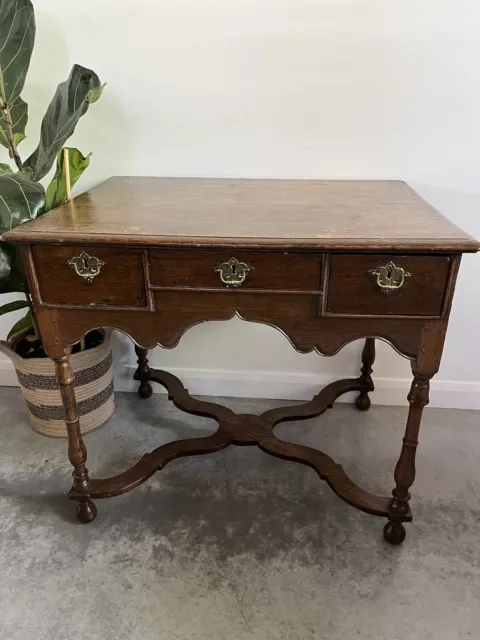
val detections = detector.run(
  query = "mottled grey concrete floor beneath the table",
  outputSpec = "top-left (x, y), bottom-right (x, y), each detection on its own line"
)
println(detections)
top-left (0, 388), bottom-right (480, 640)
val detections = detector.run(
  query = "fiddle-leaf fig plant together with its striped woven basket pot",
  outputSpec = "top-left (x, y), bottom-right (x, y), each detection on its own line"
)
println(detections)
top-left (0, 0), bottom-right (114, 436)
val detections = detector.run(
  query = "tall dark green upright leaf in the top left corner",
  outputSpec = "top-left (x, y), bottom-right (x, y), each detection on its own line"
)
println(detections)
top-left (0, 0), bottom-right (35, 147)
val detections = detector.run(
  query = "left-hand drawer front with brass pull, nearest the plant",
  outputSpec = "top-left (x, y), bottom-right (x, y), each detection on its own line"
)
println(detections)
top-left (33, 245), bottom-right (146, 307)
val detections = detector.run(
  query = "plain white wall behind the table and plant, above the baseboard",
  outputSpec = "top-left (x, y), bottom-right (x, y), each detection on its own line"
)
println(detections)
top-left (0, 0), bottom-right (480, 409)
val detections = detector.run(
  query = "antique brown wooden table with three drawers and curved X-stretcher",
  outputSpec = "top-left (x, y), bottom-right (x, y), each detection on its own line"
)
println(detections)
top-left (5, 178), bottom-right (479, 544)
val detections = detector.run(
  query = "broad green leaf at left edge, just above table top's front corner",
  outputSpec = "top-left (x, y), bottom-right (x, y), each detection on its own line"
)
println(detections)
top-left (0, 172), bottom-right (45, 233)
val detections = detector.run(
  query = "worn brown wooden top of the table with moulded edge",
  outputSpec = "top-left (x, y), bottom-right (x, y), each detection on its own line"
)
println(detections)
top-left (4, 177), bottom-right (480, 252)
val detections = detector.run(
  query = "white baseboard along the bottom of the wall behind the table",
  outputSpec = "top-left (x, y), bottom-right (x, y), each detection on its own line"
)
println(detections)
top-left (0, 360), bottom-right (480, 410)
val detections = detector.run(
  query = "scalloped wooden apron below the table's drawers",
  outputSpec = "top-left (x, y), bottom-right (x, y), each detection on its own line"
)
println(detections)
top-left (32, 291), bottom-right (424, 358)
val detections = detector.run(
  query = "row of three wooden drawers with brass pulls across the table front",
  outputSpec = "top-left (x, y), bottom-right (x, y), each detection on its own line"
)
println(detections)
top-left (33, 245), bottom-right (451, 318)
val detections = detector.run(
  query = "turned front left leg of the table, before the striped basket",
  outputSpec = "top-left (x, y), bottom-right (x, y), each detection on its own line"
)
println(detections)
top-left (53, 354), bottom-right (97, 524)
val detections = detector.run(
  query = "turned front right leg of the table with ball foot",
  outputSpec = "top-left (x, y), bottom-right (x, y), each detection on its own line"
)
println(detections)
top-left (383, 370), bottom-right (432, 544)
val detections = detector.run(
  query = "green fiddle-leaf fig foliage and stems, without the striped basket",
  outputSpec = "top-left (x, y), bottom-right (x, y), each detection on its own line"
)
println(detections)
top-left (0, 0), bottom-right (105, 344)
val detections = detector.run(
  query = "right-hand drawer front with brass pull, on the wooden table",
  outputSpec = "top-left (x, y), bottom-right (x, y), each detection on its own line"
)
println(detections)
top-left (325, 254), bottom-right (451, 317)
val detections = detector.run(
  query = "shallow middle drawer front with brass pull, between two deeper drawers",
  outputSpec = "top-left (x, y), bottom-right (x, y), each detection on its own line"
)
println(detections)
top-left (148, 250), bottom-right (322, 290)
